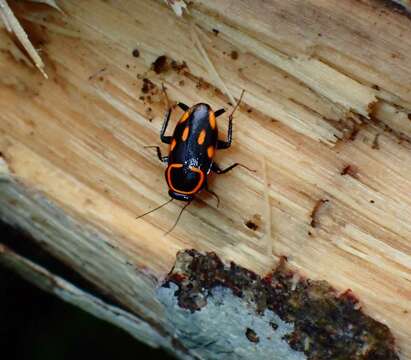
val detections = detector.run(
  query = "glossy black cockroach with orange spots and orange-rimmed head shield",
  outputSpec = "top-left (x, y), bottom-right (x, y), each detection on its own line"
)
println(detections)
top-left (137, 86), bottom-right (253, 234)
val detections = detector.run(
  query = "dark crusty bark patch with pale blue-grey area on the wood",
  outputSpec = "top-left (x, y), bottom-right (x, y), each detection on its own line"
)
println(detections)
top-left (160, 250), bottom-right (399, 360)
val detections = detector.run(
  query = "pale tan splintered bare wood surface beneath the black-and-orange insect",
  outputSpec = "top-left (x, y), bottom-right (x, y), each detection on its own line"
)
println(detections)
top-left (0, 0), bottom-right (411, 359)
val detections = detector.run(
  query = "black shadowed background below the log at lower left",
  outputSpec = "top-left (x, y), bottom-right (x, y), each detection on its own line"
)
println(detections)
top-left (0, 222), bottom-right (173, 360)
